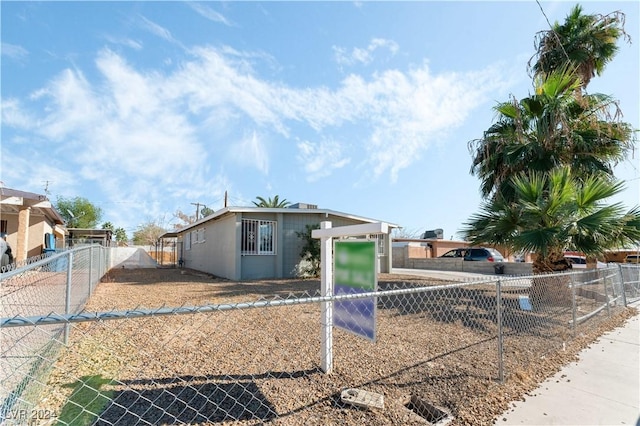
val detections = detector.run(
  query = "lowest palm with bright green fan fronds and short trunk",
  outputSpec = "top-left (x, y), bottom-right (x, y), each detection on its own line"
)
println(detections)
top-left (462, 167), bottom-right (640, 273)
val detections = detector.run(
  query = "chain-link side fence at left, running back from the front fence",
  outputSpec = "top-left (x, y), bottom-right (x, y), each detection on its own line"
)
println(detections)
top-left (0, 246), bottom-right (110, 420)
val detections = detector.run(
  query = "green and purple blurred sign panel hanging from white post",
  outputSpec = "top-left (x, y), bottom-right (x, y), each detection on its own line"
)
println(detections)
top-left (333, 240), bottom-right (378, 341)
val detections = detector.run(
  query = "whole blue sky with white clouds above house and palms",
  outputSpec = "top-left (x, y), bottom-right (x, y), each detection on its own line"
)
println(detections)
top-left (0, 1), bottom-right (640, 239)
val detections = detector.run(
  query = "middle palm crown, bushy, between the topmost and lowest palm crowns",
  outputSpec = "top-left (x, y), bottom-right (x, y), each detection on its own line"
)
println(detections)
top-left (469, 68), bottom-right (634, 201)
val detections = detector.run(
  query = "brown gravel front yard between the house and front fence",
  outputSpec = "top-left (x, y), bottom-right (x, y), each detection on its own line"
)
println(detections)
top-left (42, 269), bottom-right (631, 425)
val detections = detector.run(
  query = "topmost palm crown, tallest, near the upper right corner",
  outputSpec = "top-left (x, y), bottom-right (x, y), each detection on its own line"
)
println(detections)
top-left (529, 5), bottom-right (630, 88)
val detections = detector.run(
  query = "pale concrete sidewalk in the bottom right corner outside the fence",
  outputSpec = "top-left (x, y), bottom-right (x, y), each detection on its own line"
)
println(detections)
top-left (494, 302), bottom-right (640, 426)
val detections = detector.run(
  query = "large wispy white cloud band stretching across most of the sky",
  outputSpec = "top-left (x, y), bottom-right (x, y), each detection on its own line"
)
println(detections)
top-left (2, 41), bottom-right (500, 206)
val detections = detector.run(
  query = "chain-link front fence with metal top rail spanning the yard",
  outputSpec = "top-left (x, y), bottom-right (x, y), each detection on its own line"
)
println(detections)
top-left (0, 264), bottom-right (637, 425)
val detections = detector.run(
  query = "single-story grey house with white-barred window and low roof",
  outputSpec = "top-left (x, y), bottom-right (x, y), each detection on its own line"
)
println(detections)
top-left (168, 203), bottom-right (398, 281)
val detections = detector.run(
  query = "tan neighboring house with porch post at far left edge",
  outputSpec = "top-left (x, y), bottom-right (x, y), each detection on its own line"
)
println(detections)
top-left (0, 186), bottom-right (67, 262)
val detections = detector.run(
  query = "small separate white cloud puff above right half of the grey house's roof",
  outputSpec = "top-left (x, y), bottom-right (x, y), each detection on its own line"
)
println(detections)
top-left (297, 140), bottom-right (351, 182)
